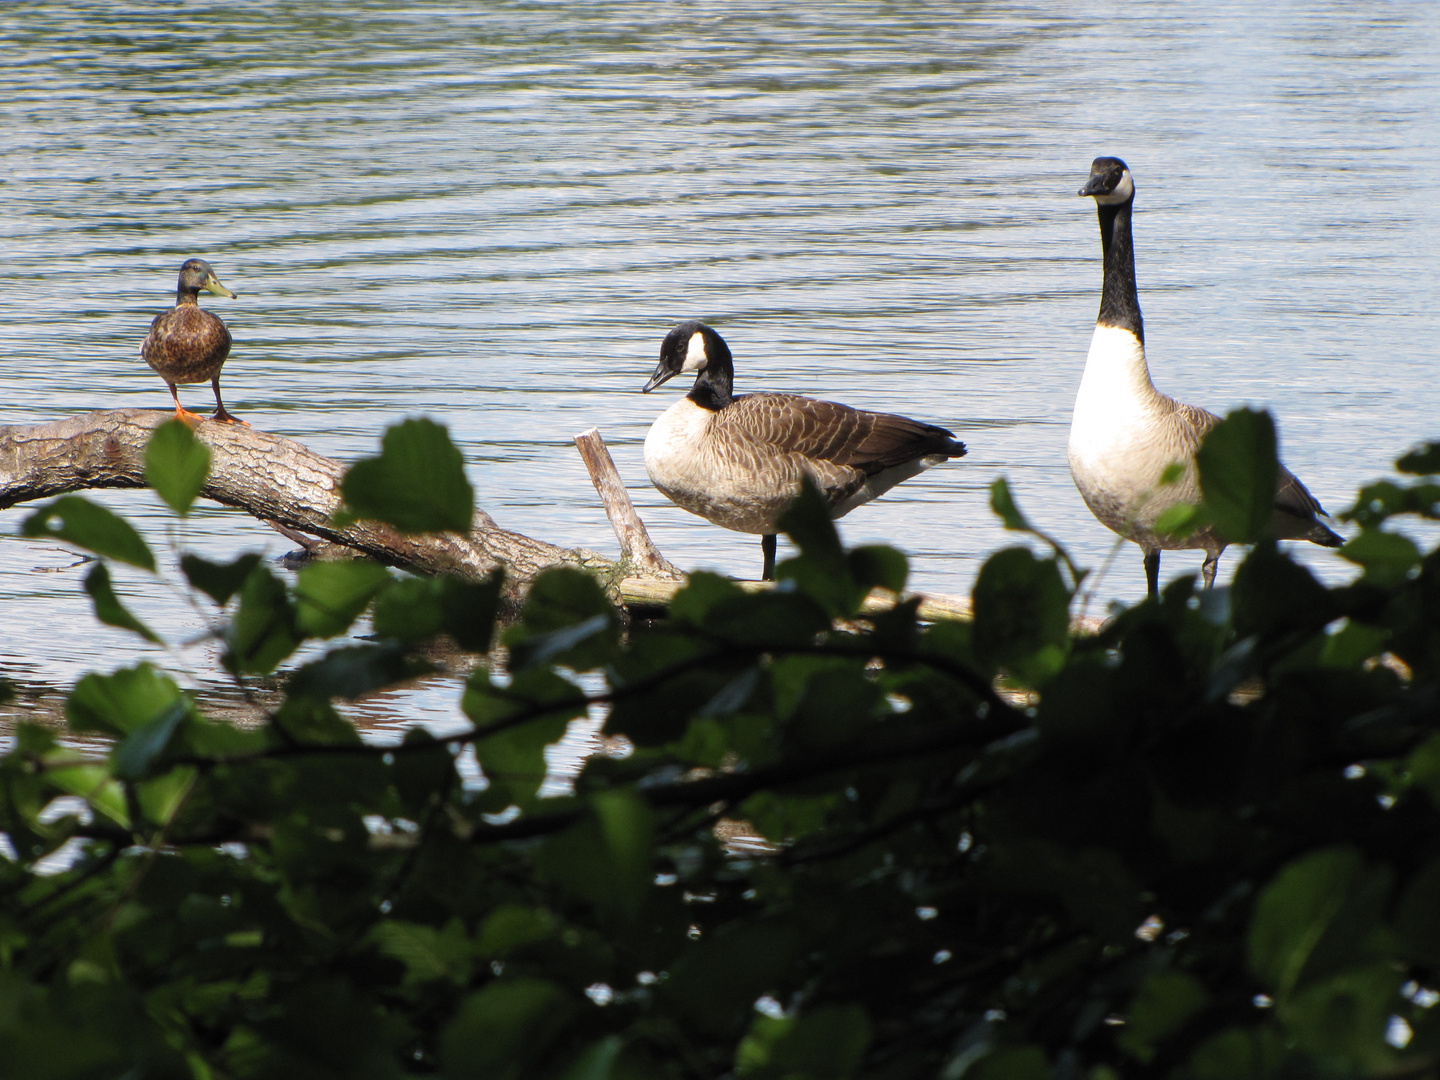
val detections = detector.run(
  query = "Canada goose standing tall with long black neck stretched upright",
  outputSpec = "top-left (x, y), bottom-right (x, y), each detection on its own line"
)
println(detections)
top-left (1070, 157), bottom-right (1342, 596)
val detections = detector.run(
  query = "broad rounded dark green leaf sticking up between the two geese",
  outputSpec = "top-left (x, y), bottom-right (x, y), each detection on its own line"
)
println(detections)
top-left (972, 547), bottom-right (1070, 684)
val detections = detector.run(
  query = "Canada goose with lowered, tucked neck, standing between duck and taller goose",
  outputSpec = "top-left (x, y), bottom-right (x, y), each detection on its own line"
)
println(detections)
top-left (642, 321), bottom-right (965, 582)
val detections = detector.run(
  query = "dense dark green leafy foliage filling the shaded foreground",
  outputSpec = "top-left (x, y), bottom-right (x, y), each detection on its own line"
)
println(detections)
top-left (0, 418), bottom-right (1440, 1080)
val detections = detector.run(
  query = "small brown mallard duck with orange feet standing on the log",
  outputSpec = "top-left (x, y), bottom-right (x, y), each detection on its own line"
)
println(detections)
top-left (140, 259), bottom-right (245, 425)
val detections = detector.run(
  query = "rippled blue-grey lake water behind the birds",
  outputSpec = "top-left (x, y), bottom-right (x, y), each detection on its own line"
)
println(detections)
top-left (0, 0), bottom-right (1440, 727)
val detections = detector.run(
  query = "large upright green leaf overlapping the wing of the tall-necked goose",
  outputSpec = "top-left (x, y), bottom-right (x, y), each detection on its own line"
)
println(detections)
top-left (1195, 409), bottom-right (1280, 544)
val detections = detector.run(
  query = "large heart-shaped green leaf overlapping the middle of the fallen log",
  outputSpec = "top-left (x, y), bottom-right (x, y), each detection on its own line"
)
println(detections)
top-left (340, 418), bottom-right (475, 533)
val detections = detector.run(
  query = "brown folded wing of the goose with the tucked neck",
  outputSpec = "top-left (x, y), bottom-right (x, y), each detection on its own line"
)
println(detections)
top-left (716, 393), bottom-right (965, 475)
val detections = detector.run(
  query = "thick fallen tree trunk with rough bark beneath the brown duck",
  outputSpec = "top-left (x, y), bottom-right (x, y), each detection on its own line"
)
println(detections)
top-left (0, 409), bottom-right (613, 585)
